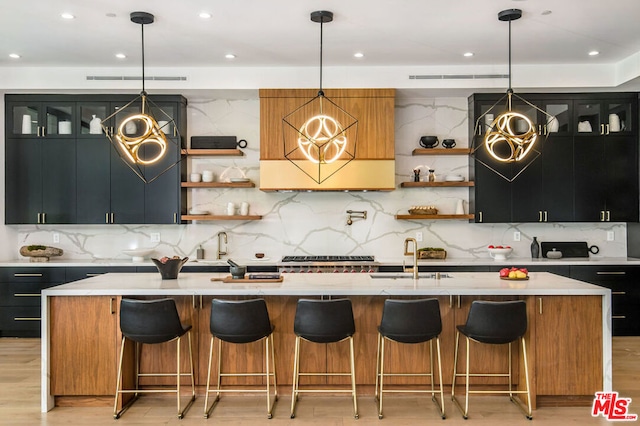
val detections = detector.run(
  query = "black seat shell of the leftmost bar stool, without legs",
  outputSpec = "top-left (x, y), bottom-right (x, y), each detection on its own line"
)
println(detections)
top-left (120, 299), bottom-right (191, 343)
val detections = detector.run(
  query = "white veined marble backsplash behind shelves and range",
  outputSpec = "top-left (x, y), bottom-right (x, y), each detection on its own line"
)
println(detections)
top-left (10, 97), bottom-right (626, 260)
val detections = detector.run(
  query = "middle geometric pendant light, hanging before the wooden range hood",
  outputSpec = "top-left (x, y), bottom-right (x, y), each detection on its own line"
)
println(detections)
top-left (282, 10), bottom-right (358, 184)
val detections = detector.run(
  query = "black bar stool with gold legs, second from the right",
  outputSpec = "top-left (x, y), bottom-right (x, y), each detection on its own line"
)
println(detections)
top-left (375, 299), bottom-right (446, 419)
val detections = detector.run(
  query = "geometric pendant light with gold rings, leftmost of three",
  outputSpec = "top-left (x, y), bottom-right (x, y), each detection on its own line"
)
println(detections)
top-left (102, 12), bottom-right (181, 183)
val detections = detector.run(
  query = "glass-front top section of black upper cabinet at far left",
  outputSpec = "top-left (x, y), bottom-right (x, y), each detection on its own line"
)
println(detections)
top-left (7, 102), bottom-right (75, 138)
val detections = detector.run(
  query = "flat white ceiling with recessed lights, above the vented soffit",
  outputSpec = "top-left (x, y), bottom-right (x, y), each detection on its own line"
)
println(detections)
top-left (0, 0), bottom-right (640, 68)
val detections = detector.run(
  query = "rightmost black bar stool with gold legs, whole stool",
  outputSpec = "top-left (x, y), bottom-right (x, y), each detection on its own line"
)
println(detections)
top-left (451, 300), bottom-right (533, 420)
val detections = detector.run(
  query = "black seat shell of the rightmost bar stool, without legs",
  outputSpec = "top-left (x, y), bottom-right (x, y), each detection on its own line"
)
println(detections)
top-left (458, 300), bottom-right (527, 344)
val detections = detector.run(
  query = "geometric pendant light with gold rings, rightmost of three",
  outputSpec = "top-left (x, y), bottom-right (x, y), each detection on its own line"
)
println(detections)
top-left (471, 9), bottom-right (553, 182)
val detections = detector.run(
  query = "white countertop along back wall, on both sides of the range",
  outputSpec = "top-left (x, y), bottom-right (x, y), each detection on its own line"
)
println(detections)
top-left (0, 256), bottom-right (640, 267)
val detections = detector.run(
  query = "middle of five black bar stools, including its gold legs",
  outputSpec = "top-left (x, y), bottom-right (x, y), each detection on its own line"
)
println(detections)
top-left (291, 299), bottom-right (359, 419)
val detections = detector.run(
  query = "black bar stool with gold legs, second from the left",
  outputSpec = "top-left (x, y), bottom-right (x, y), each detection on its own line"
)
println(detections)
top-left (204, 299), bottom-right (278, 419)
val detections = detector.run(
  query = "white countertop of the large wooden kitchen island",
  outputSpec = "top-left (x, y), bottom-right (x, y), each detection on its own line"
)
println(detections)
top-left (42, 272), bottom-right (610, 297)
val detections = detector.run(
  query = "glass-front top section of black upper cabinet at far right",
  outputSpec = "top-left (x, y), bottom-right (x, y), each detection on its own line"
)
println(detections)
top-left (574, 96), bottom-right (635, 135)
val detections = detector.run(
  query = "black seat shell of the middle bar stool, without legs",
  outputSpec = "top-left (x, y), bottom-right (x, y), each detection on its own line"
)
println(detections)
top-left (293, 299), bottom-right (356, 343)
